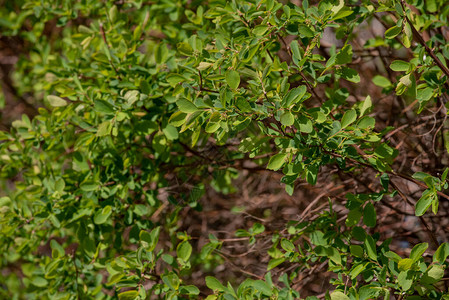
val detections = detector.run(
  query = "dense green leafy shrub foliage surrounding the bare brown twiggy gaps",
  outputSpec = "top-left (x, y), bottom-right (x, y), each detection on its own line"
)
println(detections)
top-left (0, 0), bottom-right (449, 300)
